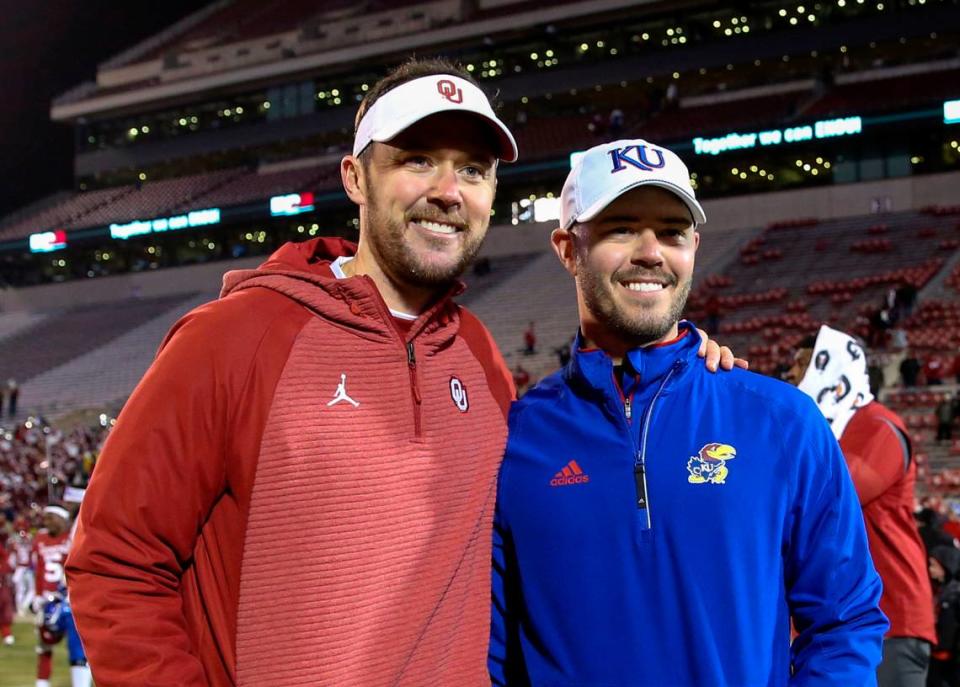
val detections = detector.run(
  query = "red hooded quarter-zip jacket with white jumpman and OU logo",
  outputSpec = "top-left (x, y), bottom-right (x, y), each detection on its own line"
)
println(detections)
top-left (67, 239), bottom-right (513, 687)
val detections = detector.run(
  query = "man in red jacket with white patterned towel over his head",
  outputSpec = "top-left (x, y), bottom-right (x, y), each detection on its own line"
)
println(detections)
top-left (787, 325), bottom-right (936, 687)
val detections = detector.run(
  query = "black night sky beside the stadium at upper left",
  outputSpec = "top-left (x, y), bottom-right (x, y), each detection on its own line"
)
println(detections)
top-left (0, 0), bottom-right (207, 217)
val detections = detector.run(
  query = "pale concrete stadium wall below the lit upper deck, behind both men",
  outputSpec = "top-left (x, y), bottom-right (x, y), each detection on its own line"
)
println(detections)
top-left (0, 172), bottom-right (960, 312)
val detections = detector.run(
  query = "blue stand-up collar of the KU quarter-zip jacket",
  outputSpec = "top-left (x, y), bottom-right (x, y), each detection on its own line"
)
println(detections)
top-left (566, 321), bottom-right (700, 396)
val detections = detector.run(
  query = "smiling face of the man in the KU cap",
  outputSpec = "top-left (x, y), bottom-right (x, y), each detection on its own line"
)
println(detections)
top-left (552, 186), bottom-right (700, 357)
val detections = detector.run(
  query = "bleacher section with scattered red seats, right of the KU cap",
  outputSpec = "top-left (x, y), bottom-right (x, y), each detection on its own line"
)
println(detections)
top-left (689, 212), bottom-right (954, 372)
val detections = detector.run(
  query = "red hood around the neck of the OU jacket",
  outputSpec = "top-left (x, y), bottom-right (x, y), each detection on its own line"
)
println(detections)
top-left (220, 237), bottom-right (463, 339)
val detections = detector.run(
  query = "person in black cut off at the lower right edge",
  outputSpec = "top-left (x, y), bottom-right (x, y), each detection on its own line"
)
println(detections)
top-left (927, 546), bottom-right (960, 687)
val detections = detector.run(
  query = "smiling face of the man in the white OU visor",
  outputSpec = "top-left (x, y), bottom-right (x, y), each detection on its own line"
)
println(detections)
top-left (343, 113), bottom-right (497, 310)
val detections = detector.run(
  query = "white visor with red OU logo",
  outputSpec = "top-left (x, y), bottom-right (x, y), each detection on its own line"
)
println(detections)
top-left (353, 74), bottom-right (517, 162)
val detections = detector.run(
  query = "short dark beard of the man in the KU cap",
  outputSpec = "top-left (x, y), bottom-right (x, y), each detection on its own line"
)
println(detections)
top-left (577, 259), bottom-right (693, 348)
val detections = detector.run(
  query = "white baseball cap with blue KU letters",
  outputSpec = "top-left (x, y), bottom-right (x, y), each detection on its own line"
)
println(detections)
top-left (560, 138), bottom-right (707, 229)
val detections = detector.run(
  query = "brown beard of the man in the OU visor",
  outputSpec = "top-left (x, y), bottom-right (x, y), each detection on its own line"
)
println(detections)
top-left (367, 187), bottom-right (489, 289)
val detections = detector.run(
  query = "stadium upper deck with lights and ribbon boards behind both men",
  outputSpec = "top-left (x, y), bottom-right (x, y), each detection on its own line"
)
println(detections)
top-left (0, 0), bottom-right (960, 283)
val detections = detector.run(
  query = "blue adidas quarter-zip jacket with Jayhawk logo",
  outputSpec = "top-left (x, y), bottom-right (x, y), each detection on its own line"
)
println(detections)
top-left (490, 323), bottom-right (887, 687)
